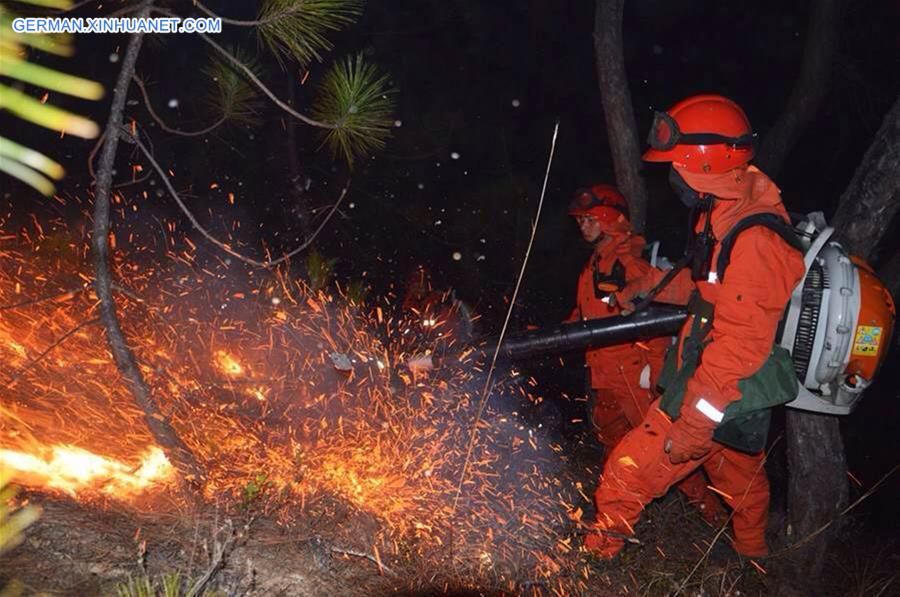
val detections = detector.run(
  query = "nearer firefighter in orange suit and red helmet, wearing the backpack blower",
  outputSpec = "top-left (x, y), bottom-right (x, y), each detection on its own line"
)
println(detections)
top-left (585, 95), bottom-right (804, 559)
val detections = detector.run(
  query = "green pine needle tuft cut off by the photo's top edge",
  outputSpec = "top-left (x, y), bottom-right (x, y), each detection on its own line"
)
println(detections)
top-left (258, 0), bottom-right (363, 64)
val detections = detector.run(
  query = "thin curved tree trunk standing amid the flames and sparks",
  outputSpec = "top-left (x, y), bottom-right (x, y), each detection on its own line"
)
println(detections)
top-left (92, 3), bottom-right (203, 483)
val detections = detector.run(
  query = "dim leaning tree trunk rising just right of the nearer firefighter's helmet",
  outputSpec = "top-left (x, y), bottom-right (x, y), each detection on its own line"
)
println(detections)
top-left (754, 0), bottom-right (841, 178)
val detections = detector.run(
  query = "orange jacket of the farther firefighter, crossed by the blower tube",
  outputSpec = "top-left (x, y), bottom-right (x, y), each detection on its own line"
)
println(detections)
top-left (568, 232), bottom-right (671, 396)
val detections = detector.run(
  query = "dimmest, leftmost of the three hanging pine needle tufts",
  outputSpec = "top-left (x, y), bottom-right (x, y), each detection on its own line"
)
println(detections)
top-left (204, 48), bottom-right (262, 126)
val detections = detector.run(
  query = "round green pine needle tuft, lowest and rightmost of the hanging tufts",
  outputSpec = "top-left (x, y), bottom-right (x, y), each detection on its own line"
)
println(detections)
top-left (312, 54), bottom-right (395, 166)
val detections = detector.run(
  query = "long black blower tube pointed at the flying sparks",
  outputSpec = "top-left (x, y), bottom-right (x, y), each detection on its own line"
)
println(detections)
top-left (500, 303), bottom-right (688, 360)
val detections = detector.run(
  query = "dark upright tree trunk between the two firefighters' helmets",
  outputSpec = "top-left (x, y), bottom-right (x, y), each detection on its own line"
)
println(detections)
top-left (594, 0), bottom-right (647, 232)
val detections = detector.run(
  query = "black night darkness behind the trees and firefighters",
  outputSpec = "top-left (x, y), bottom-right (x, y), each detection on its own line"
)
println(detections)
top-left (4, 0), bottom-right (900, 564)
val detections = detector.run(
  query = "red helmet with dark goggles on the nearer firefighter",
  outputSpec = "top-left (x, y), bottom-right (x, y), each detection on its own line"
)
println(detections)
top-left (644, 95), bottom-right (756, 174)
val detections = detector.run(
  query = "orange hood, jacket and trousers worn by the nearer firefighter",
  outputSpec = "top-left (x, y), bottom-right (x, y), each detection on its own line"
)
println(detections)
top-left (592, 166), bottom-right (804, 558)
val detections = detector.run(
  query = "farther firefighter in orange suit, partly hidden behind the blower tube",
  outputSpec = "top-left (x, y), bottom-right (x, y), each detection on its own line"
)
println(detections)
top-left (569, 185), bottom-right (724, 522)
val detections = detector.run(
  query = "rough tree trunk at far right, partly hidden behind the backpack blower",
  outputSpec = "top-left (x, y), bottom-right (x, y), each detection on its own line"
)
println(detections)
top-left (787, 92), bottom-right (900, 578)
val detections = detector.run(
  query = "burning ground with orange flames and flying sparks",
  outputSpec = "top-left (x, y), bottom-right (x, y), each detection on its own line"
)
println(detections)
top-left (0, 212), bottom-right (596, 583)
